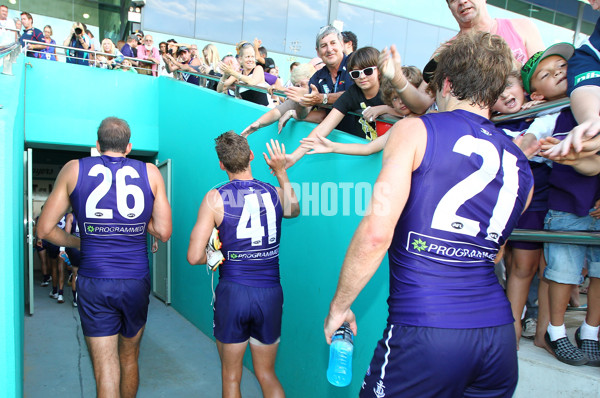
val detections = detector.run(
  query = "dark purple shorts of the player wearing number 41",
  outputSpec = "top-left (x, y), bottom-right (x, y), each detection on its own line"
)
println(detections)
top-left (213, 280), bottom-right (283, 344)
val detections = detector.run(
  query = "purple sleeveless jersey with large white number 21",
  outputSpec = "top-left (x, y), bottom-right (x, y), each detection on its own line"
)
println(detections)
top-left (388, 110), bottom-right (533, 329)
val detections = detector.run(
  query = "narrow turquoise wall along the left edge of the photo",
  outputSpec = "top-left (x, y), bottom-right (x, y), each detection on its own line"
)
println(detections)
top-left (0, 53), bottom-right (24, 397)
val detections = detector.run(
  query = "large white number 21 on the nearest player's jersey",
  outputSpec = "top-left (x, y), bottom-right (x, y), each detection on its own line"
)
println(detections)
top-left (431, 135), bottom-right (519, 242)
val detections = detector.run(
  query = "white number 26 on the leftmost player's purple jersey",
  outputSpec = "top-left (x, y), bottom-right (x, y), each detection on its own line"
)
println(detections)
top-left (85, 164), bottom-right (144, 219)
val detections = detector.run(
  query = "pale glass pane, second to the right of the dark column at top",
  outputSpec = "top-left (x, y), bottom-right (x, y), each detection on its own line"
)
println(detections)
top-left (193, 0), bottom-right (243, 44)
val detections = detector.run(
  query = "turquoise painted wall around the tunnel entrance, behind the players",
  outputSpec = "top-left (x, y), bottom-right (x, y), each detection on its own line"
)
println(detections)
top-left (0, 54), bottom-right (388, 397)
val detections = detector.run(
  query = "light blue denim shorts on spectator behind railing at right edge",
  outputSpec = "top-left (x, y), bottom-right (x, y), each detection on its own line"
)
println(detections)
top-left (544, 210), bottom-right (600, 285)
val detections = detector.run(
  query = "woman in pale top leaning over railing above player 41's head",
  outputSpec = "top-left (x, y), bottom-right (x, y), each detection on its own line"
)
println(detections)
top-left (217, 43), bottom-right (269, 106)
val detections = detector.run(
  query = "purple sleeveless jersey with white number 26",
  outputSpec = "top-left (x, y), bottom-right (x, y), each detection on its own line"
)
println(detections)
top-left (71, 155), bottom-right (154, 279)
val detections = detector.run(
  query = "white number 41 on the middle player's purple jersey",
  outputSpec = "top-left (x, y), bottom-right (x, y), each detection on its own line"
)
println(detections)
top-left (236, 192), bottom-right (277, 246)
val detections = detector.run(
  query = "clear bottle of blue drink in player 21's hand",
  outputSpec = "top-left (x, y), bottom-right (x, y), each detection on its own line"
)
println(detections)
top-left (327, 322), bottom-right (354, 387)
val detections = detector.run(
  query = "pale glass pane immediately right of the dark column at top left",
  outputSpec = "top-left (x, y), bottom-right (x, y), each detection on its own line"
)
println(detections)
top-left (143, 0), bottom-right (196, 37)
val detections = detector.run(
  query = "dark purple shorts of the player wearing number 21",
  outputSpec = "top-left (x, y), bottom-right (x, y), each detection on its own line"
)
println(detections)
top-left (359, 323), bottom-right (519, 398)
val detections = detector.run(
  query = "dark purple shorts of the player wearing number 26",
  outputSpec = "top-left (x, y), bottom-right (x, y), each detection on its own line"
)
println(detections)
top-left (77, 275), bottom-right (150, 338)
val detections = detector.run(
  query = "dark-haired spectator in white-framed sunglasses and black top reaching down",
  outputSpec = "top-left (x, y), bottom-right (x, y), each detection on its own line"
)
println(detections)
top-left (288, 47), bottom-right (384, 167)
